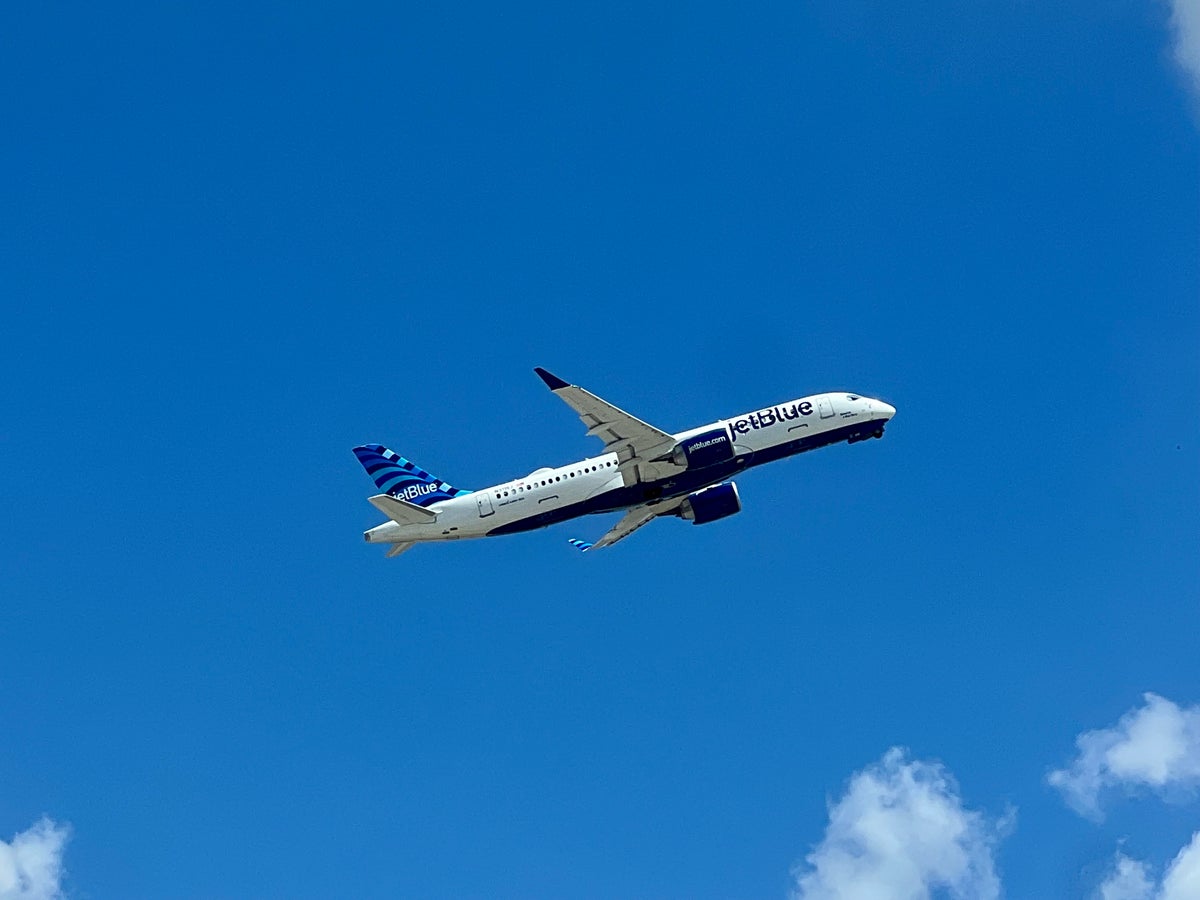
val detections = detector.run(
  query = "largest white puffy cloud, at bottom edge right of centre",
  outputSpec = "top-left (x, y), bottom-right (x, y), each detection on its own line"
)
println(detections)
top-left (792, 748), bottom-right (1013, 900)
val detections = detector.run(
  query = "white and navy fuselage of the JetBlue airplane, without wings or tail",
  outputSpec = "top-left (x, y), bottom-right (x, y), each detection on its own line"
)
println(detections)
top-left (364, 392), bottom-right (895, 554)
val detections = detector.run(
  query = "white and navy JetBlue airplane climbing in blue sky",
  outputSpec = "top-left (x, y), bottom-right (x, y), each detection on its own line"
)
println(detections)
top-left (354, 367), bottom-right (896, 557)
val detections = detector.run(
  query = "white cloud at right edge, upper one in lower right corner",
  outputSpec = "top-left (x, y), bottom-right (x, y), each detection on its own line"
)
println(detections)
top-left (1048, 694), bottom-right (1200, 820)
